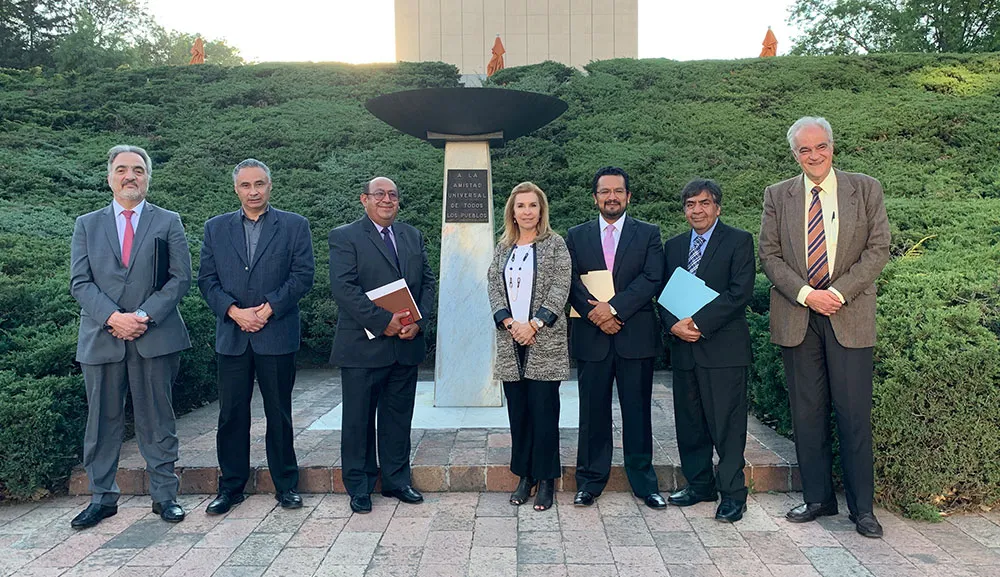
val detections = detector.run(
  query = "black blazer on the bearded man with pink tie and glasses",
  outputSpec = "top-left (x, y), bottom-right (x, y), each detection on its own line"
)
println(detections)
top-left (566, 215), bottom-right (663, 361)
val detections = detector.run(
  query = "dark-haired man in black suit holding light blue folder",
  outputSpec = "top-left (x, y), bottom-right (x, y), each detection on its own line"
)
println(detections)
top-left (659, 179), bottom-right (755, 523)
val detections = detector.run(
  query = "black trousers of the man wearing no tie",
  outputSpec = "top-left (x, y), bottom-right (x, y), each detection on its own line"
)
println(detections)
top-left (216, 344), bottom-right (299, 493)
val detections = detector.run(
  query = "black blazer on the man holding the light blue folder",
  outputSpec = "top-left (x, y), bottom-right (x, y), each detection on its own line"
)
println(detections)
top-left (660, 220), bottom-right (756, 370)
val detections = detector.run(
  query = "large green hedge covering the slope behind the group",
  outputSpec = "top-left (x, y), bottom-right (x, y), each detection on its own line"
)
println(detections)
top-left (0, 54), bottom-right (1000, 512)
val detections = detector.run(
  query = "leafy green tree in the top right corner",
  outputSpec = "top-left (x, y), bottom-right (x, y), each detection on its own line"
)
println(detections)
top-left (788, 0), bottom-right (1000, 54)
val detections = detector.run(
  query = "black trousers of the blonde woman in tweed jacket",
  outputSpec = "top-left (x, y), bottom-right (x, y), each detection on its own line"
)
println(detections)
top-left (503, 379), bottom-right (562, 481)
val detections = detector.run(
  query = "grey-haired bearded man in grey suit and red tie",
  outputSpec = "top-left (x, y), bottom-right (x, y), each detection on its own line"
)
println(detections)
top-left (70, 145), bottom-right (191, 529)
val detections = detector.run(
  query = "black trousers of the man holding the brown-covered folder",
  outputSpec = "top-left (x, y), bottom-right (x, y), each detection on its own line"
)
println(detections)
top-left (340, 363), bottom-right (417, 495)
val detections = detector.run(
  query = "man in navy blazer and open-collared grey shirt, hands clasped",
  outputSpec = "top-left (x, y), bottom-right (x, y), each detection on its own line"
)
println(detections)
top-left (198, 158), bottom-right (315, 514)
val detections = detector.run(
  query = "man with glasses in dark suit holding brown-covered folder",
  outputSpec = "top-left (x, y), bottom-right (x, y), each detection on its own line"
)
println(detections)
top-left (330, 177), bottom-right (436, 513)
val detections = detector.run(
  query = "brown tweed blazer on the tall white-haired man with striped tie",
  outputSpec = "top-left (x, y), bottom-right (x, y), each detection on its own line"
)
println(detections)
top-left (758, 170), bottom-right (889, 349)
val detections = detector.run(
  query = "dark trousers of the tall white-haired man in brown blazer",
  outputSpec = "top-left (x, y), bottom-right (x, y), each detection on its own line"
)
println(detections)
top-left (781, 311), bottom-right (875, 514)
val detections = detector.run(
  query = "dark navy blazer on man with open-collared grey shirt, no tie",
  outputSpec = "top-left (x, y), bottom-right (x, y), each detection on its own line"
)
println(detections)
top-left (198, 206), bottom-right (316, 355)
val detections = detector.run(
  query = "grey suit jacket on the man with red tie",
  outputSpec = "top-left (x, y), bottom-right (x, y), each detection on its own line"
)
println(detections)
top-left (70, 201), bottom-right (191, 365)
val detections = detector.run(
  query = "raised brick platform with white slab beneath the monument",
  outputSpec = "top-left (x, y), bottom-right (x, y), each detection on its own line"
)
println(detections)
top-left (70, 369), bottom-right (801, 495)
